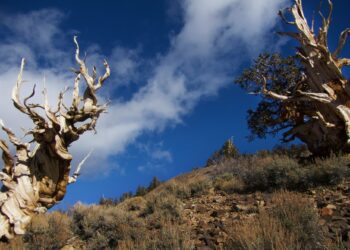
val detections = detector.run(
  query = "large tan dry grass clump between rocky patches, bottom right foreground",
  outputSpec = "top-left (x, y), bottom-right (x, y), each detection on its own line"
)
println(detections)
top-left (225, 191), bottom-right (324, 250)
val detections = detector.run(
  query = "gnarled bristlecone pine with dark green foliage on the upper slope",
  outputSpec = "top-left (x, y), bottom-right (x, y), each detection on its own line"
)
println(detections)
top-left (237, 0), bottom-right (350, 155)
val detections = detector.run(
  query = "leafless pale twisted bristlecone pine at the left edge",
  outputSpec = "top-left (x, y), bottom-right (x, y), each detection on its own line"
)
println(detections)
top-left (0, 37), bottom-right (110, 239)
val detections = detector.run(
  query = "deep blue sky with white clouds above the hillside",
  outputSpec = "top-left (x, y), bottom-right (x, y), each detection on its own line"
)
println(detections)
top-left (0, 0), bottom-right (349, 208)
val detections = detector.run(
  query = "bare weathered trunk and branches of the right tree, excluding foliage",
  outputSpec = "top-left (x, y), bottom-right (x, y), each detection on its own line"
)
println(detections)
top-left (262, 0), bottom-right (350, 155)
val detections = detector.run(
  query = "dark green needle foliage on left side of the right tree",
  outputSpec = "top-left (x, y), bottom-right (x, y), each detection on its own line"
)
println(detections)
top-left (235, 53), bottom-right (304, 142)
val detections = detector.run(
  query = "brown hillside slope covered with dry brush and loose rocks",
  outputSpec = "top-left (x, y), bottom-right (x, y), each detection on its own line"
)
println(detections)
top-left (1, 149), bottom-right (350, 249)
